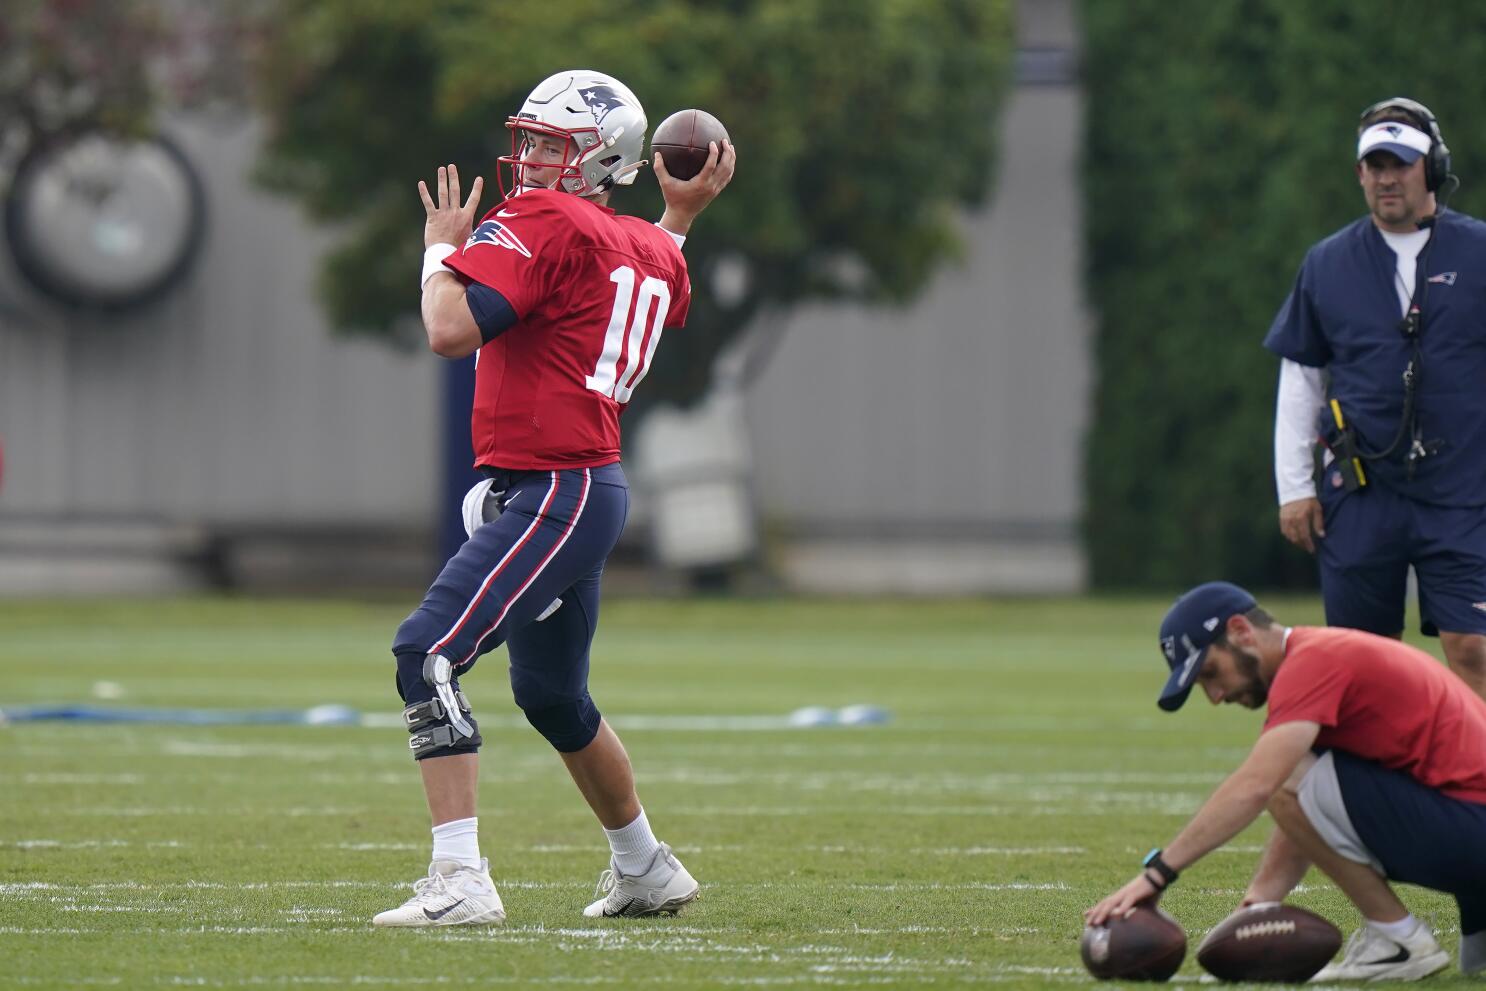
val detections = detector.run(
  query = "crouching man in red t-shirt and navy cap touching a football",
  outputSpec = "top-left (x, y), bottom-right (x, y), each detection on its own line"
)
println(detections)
top-left (1085, 582), bottom-right (1486, 981)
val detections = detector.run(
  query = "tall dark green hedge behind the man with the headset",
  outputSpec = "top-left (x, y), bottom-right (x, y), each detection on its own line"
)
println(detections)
top-left (1082, 0), bottom-right (1486, 588)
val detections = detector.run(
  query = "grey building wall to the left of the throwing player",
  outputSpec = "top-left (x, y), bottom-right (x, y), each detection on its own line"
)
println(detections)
top-left (0, 120), bottom-right (438, 591)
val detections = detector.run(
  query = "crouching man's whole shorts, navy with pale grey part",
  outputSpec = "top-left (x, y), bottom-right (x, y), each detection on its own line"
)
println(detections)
top-left (1299, 750), bottom-right (1486, 936)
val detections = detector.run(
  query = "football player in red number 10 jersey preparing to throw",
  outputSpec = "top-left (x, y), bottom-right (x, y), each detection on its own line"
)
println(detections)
top-left (373, 70), bottom-right (736, 926)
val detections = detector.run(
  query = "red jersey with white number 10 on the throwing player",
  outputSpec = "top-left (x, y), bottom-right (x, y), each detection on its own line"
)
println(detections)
top-left (444, 189), bottom-right (691, 469)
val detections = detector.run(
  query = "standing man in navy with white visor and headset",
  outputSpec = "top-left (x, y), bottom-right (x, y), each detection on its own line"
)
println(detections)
top-left (1265, 98), bottom-right (1486, 697)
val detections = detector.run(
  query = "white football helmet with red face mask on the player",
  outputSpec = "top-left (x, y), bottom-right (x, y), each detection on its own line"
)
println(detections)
top-left (496, 68), bottom-right (648, 196)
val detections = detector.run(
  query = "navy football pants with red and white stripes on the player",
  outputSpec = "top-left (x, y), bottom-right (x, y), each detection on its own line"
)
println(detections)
top-left (392, 464), bottom-right (629, 709)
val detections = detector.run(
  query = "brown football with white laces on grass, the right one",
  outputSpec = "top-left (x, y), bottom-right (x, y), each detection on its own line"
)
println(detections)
top-left (1198, 902), bottom-right (1342, 984)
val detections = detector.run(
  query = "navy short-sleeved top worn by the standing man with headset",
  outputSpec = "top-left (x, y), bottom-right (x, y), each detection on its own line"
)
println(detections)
top-left (1265, 209), bottom-right (1486, 507)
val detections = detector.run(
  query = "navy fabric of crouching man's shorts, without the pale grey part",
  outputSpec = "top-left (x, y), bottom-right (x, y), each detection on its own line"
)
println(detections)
top-left (1331, 750), bottom-right (1486, 936)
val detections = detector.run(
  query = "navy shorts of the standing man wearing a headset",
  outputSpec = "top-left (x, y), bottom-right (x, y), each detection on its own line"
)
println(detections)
top-left (1317, 468), bottom-right (1486, 636)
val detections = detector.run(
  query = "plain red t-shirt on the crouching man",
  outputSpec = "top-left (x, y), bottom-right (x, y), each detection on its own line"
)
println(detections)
top-left (1265, 627), bottom-right (1486, 802)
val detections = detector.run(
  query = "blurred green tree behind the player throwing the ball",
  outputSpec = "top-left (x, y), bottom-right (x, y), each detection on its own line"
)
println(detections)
top-left (257, 0), bottom-right (1012, 401)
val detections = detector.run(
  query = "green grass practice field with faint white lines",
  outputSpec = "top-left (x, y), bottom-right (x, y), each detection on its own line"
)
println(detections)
top-left (0, 599), bottom-right (1482, 988)
